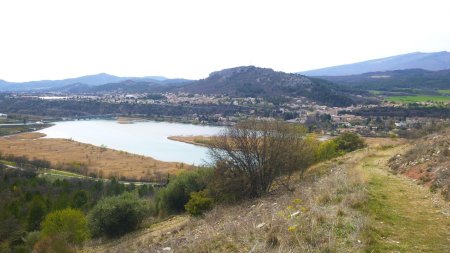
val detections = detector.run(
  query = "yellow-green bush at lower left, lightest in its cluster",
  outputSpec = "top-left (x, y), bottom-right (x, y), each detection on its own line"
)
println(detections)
top-left (41, 208), bottom-right (89, 245)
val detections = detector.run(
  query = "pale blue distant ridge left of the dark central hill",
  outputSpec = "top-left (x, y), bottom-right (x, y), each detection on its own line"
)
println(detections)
top-left (0, 73), bottom-right (189, 91)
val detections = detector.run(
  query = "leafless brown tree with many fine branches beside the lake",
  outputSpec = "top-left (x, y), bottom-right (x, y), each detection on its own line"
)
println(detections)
top-left (209, 120), bottom-right (314, 197)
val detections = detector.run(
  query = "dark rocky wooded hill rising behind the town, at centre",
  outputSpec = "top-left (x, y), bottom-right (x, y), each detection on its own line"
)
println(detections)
top-left (176, 66), bottom-right (355, 106)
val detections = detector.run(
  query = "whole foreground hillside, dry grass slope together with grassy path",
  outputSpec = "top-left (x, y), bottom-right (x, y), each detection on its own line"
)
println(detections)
top-left (82, 139), bottom-right (450, 252)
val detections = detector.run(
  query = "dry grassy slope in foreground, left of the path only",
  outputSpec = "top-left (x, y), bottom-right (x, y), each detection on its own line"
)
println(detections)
top-left (85, 149), bottom-right (367, 252)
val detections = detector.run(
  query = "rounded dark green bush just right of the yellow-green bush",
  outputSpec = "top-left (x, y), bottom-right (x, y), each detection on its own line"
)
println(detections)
top-left (88, 193), bottom-right (149, 237)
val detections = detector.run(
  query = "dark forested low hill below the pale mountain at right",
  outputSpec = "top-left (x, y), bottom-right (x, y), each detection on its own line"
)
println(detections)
top-left (314, 69), bottom-right (450, 90)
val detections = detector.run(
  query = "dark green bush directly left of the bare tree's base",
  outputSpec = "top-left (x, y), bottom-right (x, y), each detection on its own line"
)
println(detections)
top-left (155, 168), bottom-right (213, 216)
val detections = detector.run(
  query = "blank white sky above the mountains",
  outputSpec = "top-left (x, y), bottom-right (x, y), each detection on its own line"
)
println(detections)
top-left (0, 0), bottom-right (450, 81)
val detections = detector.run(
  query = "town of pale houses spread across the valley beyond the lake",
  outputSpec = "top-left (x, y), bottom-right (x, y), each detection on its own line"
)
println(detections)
top-left (0, 92), bottom-right (448, 137)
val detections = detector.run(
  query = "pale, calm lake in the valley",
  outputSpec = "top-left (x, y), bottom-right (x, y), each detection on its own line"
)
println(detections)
top-left (38, 120), bottom-right (222, 165)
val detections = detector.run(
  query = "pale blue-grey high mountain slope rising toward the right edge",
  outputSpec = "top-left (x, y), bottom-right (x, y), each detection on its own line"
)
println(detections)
top-left (299, 51), bottom-right (450, 76)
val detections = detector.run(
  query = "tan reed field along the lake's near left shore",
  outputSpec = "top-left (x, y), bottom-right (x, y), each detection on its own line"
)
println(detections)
top-left (0, 133), bottom-right (189, 181)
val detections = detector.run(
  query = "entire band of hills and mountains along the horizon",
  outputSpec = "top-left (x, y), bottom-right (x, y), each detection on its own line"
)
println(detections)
top-left (0, 52), bottom-right (450, 106)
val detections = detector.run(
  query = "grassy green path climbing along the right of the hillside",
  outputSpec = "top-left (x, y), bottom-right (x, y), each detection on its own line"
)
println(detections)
top-left (356, 146), bottom-right (450, 253)
